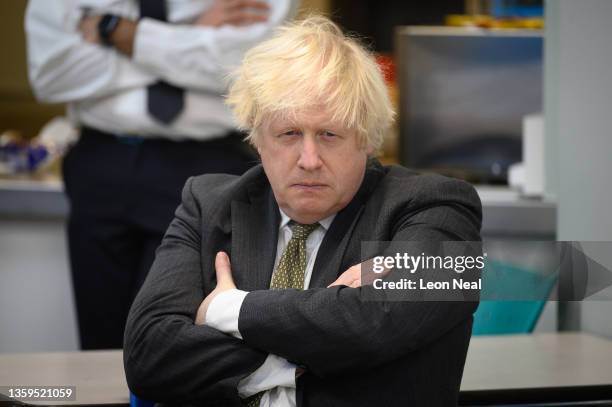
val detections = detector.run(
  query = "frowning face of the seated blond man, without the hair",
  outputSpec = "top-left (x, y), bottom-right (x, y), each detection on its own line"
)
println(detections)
top-left (257, 107), bottom-right (371, 223)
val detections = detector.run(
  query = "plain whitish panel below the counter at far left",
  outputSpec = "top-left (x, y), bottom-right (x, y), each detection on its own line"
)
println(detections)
top-left (0, 219), bottom-right (79, 352)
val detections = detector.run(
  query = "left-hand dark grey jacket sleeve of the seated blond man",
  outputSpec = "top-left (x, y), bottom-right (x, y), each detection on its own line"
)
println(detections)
top-left (124, 179), bottom-right (267, 406)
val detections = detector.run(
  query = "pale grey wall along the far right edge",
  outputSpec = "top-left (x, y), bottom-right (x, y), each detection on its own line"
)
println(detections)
top-left (545, 0), bottom-right (612, 337)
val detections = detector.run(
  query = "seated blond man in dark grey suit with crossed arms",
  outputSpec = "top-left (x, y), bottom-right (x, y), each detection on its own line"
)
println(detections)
top-left (124, 17), bottom-right (481, 407)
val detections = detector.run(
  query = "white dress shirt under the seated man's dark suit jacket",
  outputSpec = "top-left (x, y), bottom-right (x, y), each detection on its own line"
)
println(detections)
top-left (206, 210), bottom-right (336, 407)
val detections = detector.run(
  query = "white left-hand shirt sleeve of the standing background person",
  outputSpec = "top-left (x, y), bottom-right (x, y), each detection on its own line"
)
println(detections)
top-left (25, 0), bottom-right (156, 102)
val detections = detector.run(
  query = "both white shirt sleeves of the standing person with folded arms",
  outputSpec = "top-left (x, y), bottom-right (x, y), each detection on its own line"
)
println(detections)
top-left (26, 0), bottom-right (294, 102)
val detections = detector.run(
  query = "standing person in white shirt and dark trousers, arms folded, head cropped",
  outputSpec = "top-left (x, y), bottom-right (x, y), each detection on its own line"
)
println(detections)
top-left (25, 0), bottom-right (295, 349)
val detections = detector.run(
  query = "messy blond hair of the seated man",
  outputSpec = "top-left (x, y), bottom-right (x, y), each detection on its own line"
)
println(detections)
top-left (226, 16), bottom-right (394, 150)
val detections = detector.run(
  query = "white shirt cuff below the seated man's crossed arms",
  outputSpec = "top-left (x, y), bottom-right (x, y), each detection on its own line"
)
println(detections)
top-left (238, 355), bottom-right (296, 398)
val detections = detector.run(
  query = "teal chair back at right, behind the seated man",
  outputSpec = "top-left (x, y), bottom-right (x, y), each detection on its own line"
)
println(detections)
top-left (472, 260), bottom-right (558, 335)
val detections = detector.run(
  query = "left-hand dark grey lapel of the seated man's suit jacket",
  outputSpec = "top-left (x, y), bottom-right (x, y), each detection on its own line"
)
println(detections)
top-left (232, 186), bottom-right (280, 291)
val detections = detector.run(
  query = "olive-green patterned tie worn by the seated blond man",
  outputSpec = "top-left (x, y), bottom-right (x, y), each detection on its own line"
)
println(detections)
top-left (244, 222), bottom-right (319, 407)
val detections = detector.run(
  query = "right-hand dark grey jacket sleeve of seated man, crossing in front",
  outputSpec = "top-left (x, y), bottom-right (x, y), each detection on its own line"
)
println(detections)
top-left (239, 180), bottom-right (481, 377)
